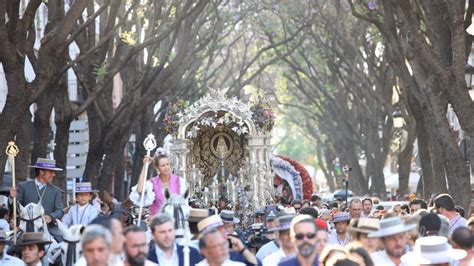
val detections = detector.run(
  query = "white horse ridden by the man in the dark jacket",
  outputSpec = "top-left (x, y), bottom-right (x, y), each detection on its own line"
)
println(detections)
top-left (18, 202), bottom-right (60, 265)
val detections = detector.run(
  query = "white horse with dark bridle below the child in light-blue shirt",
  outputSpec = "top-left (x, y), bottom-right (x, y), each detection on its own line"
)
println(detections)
top-left (50, 220), bottom-right (85, 266)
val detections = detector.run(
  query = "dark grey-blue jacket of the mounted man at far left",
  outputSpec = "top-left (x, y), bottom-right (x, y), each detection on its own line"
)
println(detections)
top-left (17, 180), bottom-right (64, 222)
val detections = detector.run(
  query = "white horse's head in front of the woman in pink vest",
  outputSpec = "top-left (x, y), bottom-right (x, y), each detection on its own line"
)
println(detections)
top-left (161, 189), bottom-right (190, 236)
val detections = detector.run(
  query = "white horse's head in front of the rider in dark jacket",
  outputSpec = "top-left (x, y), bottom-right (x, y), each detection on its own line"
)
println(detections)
top-left (18, 202), bottom-right (45, 232)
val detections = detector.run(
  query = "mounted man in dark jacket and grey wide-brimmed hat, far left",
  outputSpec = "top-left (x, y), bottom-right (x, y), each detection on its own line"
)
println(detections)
top-left (10, 158), bottom-right (63, 242)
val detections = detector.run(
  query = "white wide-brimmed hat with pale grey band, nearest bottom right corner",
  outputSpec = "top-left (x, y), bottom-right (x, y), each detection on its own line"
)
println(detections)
top-left (401, 236), bottom-right (467, 265)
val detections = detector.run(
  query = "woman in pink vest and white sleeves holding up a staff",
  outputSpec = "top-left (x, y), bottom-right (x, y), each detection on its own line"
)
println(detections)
top-left (130, 148), bottom-right (187, 216)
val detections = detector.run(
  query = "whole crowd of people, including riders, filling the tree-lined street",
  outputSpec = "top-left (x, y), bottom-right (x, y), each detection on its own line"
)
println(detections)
top-left (0, 155), bottom-right (474, 266)
